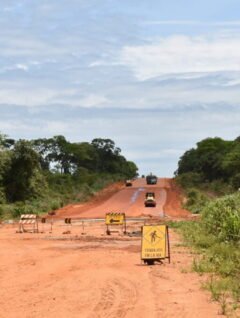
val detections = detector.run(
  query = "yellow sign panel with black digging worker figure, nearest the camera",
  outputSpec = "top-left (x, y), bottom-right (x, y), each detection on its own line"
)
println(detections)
top-left (141, 225), bottom-right (169, 260)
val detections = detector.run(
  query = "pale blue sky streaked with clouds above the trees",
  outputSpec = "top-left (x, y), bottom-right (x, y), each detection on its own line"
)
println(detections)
top-left (0, 0), bottom-right (240, 176)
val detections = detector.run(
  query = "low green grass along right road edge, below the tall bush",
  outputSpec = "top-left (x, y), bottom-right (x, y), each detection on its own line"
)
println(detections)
top-left (167, 221), bottom-right (240, 316)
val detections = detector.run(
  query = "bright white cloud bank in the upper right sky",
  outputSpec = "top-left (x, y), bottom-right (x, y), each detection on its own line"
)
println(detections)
top-left (120, 36), bottom-right (240, 81)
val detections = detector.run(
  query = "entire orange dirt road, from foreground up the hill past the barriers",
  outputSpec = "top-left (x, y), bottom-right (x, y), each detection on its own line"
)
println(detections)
top-left (0, 179), bottom-right (219, 318)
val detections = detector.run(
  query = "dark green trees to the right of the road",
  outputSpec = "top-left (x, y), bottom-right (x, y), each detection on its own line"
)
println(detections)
top-left (175, 137), bottom-right (240, 188)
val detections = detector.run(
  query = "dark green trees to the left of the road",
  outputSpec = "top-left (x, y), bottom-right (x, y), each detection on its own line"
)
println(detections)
top-left (0, 134), bottom-right (138, 204)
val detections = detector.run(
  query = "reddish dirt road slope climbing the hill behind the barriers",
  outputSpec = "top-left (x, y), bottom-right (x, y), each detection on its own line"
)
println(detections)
top-left (56, 178), bottom-right (191, 218)
